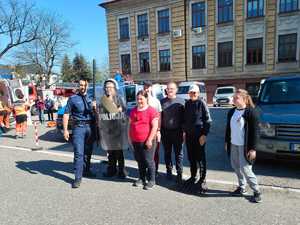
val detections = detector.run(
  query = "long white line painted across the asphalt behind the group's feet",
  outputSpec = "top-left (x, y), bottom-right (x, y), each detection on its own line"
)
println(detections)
top-left (0, 145), bottom-right (300, 194)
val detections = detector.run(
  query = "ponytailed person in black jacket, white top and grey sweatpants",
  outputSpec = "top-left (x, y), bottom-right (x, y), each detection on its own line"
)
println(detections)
top-left (225, 89), bottom-right (261, 202)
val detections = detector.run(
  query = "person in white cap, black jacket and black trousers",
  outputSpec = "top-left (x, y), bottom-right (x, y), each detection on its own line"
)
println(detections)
top-left (184, 85), bottom-right (211, 193)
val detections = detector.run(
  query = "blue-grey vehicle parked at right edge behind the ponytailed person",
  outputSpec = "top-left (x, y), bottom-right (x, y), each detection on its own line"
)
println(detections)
top-left (256, 74), bottom-right (300, 160)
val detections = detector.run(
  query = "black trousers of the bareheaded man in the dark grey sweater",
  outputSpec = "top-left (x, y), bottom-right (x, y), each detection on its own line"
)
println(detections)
top-left (161, 130), bottom-right (183, 174)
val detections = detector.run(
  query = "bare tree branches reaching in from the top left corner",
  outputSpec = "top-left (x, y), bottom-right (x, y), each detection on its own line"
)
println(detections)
top-left (0, 0), bottom-right (41, 59)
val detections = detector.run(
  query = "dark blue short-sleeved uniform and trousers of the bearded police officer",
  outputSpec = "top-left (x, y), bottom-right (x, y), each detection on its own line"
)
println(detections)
top-left (65, 93), bottom-right (94, 180)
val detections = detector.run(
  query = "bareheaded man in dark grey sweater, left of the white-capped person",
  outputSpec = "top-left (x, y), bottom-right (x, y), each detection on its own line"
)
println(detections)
top-left (161, 82), bottom-right (184, 183)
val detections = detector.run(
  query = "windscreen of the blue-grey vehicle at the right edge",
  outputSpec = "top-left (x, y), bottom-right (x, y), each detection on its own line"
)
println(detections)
top-left (259, 79), bottom-right (300, 104)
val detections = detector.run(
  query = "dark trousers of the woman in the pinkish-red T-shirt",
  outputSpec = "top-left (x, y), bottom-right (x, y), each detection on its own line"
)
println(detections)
top-left (132, 141), bottom-right (156, 183)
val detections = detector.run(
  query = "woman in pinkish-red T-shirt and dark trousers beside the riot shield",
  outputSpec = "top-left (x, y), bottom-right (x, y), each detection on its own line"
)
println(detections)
top-left (129, 91), bottom-right (159, 190)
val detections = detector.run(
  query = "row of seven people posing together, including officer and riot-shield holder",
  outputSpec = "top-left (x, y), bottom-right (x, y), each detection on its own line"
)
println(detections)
top-left (63, 79), bottom-right (261, 202)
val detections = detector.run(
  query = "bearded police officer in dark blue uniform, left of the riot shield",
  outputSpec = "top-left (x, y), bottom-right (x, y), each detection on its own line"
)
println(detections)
top-left (63, 78), bottom-right (96, 188)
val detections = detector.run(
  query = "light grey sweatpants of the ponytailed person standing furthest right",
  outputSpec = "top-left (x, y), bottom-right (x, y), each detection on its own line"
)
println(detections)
top-left (230, 144), bottom-right (259, 192)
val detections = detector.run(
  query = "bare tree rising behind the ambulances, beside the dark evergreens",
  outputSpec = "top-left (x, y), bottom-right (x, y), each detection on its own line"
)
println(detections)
top-left (16, 14), bottom-right (73, 84)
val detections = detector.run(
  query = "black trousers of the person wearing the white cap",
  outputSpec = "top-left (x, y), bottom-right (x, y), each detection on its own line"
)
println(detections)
top-left (186, 134), bottom-right (206, 183)
